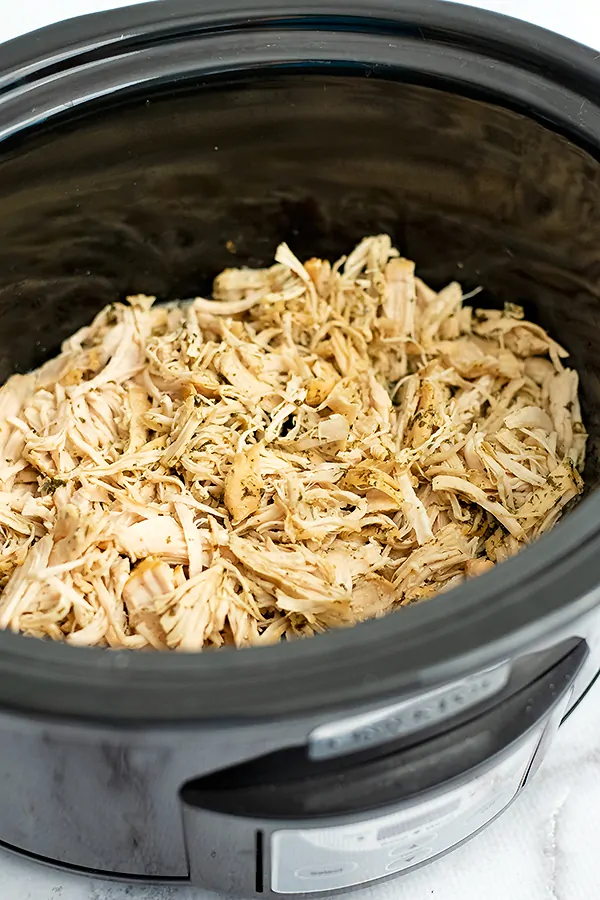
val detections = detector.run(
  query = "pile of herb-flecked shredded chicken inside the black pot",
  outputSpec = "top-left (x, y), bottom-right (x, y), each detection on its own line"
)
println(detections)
top-left (0, 235), bottom-right (586, 651)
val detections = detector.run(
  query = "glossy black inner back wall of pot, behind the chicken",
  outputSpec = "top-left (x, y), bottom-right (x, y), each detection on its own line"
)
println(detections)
top-left (5, 51), bottom-right (600, 454)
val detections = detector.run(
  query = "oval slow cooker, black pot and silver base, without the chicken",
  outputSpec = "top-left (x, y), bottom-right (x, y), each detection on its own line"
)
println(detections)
top-left (0, 0), bottom-right (600, 898)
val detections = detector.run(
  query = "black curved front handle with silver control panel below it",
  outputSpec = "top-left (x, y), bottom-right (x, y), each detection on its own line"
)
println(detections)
top-left (181, 641), bottom-right (588, 897)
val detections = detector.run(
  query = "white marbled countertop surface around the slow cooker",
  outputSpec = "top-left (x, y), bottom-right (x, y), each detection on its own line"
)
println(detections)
top-left (0, 0), bottom-right (600, 900)
